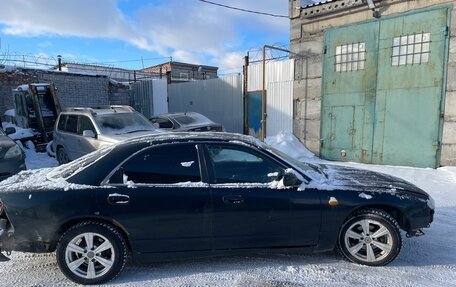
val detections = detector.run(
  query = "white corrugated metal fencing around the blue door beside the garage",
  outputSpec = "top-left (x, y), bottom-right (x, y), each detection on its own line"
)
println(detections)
top-left (247, 59), bottom-right (294, 136)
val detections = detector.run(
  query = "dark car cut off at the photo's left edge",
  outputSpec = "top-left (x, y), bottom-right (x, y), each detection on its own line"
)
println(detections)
top-left (0, 127), bottom-right (25, 181)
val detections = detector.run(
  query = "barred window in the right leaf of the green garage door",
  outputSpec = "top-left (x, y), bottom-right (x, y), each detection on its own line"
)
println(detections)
top-left (391, 33), bottom-right (431, 66)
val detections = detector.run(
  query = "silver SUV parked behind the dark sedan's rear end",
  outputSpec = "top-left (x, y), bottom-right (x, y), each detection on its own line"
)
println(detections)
top-left (53, 106), bottom-right (157, 164)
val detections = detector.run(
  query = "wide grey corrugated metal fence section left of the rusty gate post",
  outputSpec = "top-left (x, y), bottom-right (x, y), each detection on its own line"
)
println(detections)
top-left (168, 75), bottom-right (244, 133)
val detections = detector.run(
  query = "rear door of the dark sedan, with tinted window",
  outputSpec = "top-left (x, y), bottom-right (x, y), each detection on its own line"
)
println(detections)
top-left (98, 144), bottom-right (211, 253)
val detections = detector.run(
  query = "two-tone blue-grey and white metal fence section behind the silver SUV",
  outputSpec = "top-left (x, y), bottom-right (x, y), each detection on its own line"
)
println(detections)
top-left (130, 79), bottom-right (168, 118)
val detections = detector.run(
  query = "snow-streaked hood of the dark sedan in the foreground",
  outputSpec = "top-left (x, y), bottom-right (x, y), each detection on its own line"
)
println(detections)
top-left (320, 165), bottom-right (429, 196)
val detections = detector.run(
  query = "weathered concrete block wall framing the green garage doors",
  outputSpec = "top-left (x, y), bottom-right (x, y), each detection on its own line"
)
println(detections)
top-left (289, 0), bottom-right (456, 165)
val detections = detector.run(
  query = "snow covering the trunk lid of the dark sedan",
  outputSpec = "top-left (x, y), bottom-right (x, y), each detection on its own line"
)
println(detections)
top-left (0, 168), bottom-right (95, 193)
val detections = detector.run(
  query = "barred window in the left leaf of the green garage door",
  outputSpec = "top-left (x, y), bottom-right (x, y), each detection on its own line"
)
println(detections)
top-left (336, 42), bottom-right (366, 72)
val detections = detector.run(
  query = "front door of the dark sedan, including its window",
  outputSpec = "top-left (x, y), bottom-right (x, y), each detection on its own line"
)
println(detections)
top-left (205, 144), bottom-right (320, 249)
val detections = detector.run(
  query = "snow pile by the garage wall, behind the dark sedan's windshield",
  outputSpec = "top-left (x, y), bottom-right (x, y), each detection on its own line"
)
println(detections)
top-left (265, 132), bottom-right (318, 162)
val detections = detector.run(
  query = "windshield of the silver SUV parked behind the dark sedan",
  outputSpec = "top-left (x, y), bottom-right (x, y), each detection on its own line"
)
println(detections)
top-left (94, 113), bottom-right (155, 135)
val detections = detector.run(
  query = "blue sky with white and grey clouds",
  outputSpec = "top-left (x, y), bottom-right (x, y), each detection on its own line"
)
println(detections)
top-left (0, 0), bottom-right (289, 74)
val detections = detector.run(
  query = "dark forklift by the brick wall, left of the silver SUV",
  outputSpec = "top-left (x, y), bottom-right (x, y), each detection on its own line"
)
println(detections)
top-left (13, 84), bottom-right (61, 151)
